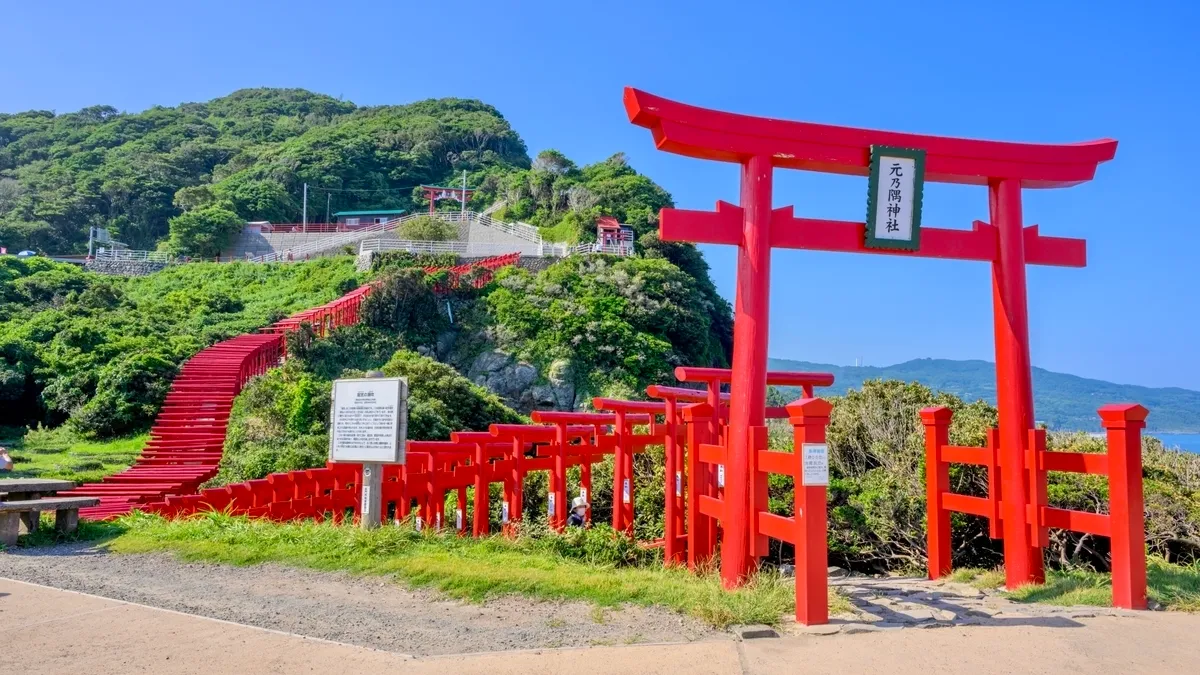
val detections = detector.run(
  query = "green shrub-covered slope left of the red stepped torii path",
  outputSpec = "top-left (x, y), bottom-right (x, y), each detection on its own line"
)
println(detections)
top-left (0, 256), bottom-right (357, 436)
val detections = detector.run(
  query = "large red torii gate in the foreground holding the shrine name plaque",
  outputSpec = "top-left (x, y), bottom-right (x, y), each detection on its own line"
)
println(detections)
top-left (624, 88), bottom-right (1117, 589)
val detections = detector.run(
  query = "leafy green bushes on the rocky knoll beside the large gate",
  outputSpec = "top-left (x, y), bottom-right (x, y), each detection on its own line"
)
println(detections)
top-left (486, 256), bottom-right (731, 400)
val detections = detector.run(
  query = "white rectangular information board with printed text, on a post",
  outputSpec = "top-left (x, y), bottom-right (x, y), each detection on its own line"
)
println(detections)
top-left (329, 377), bottom-right (408, 464)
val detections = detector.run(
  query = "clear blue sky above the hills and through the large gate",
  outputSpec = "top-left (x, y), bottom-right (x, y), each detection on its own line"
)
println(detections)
top-left (7, 0), bottom-right (1200, 389)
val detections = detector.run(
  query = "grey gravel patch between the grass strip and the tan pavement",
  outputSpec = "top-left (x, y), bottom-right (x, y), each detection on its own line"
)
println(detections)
top-left (0, 544), bottom-right (726, 656)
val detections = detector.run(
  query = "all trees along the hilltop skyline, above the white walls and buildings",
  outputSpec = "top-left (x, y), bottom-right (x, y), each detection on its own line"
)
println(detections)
top-left (0, 89), bottom-right (671, 256)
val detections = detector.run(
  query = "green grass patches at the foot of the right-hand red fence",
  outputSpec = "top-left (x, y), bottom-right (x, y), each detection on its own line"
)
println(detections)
top-left (950, 556), bottom-right (1200, 611)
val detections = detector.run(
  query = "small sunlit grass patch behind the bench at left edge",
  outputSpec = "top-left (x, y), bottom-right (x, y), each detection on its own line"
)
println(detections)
top-left (0, 426), bottom-right (148, 483)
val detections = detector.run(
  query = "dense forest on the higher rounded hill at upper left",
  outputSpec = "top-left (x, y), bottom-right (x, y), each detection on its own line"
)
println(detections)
top-left (0, 89), bottom-right (529, 252)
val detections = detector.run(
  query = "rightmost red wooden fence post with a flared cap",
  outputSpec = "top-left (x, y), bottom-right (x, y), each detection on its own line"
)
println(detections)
top-left (1099, 404), bottom-right (1150, 609)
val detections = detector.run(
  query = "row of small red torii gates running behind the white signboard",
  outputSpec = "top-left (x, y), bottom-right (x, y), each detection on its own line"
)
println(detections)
top-left (148, 368), bottom-right (833, 623)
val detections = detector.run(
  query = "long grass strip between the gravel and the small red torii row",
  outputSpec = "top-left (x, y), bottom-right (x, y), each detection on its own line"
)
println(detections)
top-left (39, 514), bottom-right (806, 627)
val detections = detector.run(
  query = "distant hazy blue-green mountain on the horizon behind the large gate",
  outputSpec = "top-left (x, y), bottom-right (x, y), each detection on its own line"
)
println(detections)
top-left (768, 359), bottom-right (1200, 434)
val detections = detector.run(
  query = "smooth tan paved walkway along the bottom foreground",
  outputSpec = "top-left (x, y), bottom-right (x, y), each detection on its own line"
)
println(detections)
top-left (0, 578), bottom-right (1200, 675)
